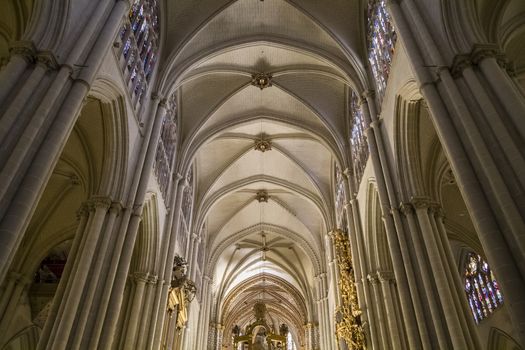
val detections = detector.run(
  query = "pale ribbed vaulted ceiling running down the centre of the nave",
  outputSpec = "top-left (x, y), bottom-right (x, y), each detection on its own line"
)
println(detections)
top-left (161, 0), bottom-right (366, 342)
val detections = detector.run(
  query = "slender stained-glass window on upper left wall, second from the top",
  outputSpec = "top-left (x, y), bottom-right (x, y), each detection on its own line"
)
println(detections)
top-left (154, 94), bottom-right (177, 201)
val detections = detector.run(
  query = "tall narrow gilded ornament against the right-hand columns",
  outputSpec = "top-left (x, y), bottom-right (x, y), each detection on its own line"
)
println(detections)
top-left (330, 229), bottom-right (366, 350)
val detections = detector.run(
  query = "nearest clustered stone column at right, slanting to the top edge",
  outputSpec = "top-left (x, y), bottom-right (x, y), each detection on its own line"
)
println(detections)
top-left (387, 0), bottom-right (525, 343)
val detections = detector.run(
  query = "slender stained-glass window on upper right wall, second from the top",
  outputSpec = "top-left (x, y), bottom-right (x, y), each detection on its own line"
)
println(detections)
top-left (350, 91), bottom-right (369, 187)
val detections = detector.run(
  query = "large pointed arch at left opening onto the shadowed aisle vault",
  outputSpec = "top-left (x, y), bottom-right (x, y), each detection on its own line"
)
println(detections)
top-left (0, 89), bottom-right (128, 348)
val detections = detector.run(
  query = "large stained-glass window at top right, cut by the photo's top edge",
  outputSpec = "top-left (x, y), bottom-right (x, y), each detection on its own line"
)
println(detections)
top-left (368, 0), bottom-right (396, 103)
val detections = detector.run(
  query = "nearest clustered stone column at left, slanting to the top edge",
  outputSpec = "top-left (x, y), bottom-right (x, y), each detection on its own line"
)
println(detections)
top-left (0, 0), bottom-right (129, 281)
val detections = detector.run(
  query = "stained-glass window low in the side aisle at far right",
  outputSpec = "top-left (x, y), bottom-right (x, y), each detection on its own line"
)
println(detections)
top-left (465, 253), bottom-right (503, 323)
